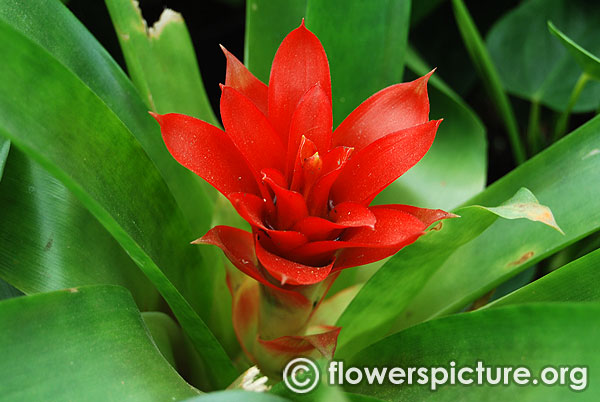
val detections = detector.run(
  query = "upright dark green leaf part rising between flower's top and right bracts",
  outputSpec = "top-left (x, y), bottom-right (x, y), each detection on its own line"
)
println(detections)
top-left (306, 0), bottom-right (411, 126)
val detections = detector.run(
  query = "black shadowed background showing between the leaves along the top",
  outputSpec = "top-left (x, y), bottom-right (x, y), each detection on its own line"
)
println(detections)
top-left (67, 0), bottom-right (556, 183)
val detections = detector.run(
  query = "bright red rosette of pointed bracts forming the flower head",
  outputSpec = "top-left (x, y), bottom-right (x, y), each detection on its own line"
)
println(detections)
top-left (154, 24), bottom-right (449, 288)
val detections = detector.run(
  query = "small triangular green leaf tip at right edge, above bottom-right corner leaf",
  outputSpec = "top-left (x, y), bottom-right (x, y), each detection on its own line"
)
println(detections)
top-left (485, 249), bottom-right (600, 308)
